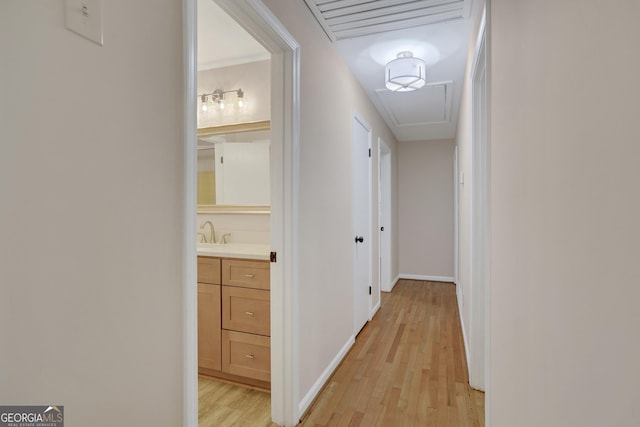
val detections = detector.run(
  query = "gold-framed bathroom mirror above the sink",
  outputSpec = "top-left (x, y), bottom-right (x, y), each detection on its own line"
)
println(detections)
top-left (198, 120), bottom-right (271, 213)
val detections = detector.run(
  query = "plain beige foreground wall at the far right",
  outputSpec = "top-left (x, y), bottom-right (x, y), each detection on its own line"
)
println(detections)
top-left (488, 0), bottom-right (640, 427)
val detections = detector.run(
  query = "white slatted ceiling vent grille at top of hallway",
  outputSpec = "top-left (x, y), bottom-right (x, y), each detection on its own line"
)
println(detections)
top-left (305, 0), bottom-right (471, 42)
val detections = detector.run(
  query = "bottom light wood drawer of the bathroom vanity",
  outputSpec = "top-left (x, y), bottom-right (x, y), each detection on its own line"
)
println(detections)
top-left (222, 330), bottom-right (271, 381)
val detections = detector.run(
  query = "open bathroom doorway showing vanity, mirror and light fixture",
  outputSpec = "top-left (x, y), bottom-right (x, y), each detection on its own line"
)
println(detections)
top-left (196, 0), bottom-right (272, 425)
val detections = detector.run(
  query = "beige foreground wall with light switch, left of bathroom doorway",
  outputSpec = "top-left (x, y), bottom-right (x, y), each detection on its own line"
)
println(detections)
top-left (0, 0), bottom-right (183, 427)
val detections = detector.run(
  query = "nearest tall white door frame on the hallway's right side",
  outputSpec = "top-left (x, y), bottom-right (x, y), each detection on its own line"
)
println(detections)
top-left (469, 7), bottom-right (490, 390)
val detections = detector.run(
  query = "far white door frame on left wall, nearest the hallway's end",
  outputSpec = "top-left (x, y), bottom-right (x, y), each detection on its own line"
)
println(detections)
top-left (378, 138), bottom-right (393, 292)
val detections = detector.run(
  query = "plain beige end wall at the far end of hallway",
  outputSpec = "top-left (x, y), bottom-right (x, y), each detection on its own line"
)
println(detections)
top-left (398, 140), bottom-right (455, 280)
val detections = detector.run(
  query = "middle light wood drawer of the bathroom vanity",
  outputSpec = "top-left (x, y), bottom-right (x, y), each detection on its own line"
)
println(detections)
top-left (222, 286), bottom-right (271, 335)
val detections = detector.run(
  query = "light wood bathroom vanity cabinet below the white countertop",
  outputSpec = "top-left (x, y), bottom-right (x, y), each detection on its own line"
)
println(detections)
top-left (198, 256), bottom-right (271, 390)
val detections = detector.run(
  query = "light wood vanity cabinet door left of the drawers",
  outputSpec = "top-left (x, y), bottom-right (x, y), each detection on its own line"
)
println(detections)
top-left (198, 283), bottom-right (222, 371)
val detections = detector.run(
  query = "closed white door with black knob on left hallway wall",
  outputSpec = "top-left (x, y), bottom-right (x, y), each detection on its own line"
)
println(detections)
top-left (351, 115), bottom-right (371, 335)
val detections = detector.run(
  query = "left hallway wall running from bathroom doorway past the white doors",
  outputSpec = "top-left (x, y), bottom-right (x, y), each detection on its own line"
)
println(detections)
top-left (264, 0), bottom-right (397, 414)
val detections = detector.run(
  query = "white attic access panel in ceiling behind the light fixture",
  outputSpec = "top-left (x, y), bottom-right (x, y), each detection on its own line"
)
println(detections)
top-left (376, 82), bottom-right (453, 127)
